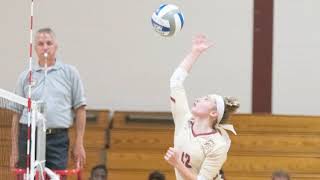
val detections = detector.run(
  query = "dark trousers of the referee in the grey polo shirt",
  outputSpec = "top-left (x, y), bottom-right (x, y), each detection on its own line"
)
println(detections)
top-left (18, 124), bottom-right (69, 170)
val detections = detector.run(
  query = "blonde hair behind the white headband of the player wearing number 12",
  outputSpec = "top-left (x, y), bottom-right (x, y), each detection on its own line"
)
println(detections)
top-left (220, 97), bottom-right (240, 124)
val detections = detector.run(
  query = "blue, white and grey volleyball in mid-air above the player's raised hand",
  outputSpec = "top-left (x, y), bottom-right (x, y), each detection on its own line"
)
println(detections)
top-left (151, 4), bottom-right (184, 37)
